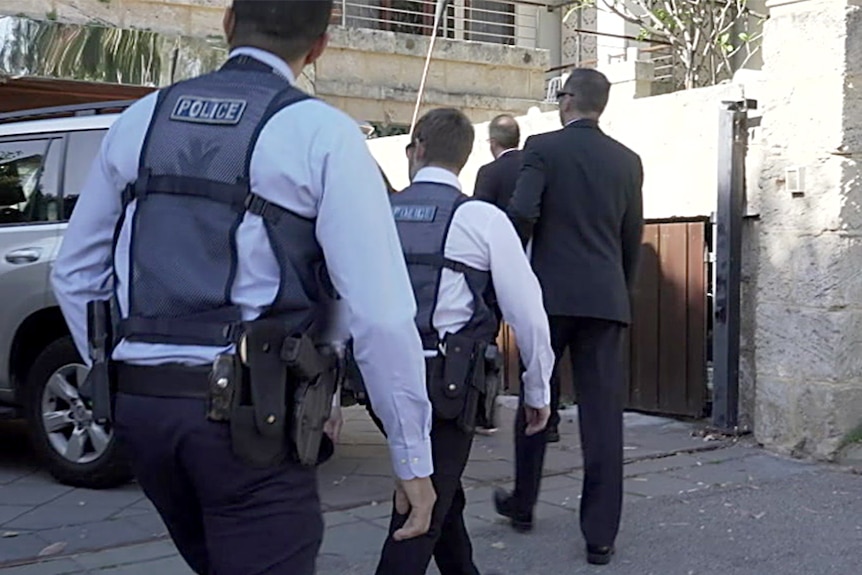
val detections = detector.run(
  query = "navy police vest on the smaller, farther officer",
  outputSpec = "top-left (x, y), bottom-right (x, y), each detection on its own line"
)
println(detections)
top-left (389, 182), bottom-right (499, 350)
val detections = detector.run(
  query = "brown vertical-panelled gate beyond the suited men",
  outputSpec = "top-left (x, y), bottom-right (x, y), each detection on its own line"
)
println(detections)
top-left (499, 218), bottom-right (710, 417)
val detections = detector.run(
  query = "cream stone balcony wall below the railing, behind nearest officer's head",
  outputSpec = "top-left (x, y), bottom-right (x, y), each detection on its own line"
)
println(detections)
top-left (0, 0), bottom-right (549, 124)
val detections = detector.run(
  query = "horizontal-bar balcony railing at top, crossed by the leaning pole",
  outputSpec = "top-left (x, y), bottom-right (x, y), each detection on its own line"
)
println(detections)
top-left (332, 0), bottom-right (540, 48)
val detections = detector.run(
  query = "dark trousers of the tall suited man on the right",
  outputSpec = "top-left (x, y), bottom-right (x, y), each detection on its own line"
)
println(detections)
top-left (514, 316), bottom-right (625, 546)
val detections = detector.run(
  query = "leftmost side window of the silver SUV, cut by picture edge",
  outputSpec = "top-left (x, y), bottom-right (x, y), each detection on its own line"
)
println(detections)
top-left (0, 138), bottom-right (62, 225)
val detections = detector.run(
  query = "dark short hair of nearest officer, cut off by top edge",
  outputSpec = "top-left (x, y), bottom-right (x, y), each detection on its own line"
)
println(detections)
top-left (233, 0), bottom-right (333, 60)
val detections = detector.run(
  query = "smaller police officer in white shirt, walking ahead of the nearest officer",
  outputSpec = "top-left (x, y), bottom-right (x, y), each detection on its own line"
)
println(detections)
top-left (371, 109), bottom-right (554, 575)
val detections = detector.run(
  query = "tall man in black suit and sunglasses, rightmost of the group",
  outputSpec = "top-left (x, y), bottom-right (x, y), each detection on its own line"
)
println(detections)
top-left (495, 69), bottom-right (643, 564)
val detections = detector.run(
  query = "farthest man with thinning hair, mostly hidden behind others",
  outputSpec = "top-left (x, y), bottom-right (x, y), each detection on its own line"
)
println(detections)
top-left (473, 114), bottom-right (521, 210)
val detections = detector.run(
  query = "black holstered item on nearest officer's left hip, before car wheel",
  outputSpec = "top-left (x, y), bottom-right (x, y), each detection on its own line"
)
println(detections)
top-left (80, 300), bottom-right (115, 425)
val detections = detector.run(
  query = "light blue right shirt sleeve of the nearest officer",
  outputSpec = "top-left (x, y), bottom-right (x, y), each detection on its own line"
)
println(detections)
top-left (313, 127), bottom-right (433, 479)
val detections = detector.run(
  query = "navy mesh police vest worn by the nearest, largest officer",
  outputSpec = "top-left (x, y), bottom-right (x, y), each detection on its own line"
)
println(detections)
top-left (115, 56), bottom-right (329, 347)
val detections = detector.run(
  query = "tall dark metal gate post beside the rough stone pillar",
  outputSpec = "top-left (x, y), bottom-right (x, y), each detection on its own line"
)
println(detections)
top-left (712, 100), bottom-right (757, 432)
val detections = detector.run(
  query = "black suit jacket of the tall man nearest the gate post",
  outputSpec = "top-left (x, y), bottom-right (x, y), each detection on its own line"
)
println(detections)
top-left (508, 120), bottom-right (644, 324)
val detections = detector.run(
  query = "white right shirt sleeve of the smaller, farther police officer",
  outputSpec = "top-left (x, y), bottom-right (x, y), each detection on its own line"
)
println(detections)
top-left (487, 212), bottom-right (554, 408)
